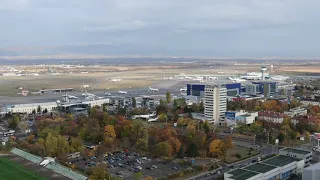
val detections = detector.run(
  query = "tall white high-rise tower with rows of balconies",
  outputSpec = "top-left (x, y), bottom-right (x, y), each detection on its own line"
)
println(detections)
top-left (204, 85), bottom-right (227, 124)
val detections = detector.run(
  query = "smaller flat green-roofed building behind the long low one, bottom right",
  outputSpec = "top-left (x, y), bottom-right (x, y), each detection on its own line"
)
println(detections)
top-left (279, 148), bottom-right (312, 166)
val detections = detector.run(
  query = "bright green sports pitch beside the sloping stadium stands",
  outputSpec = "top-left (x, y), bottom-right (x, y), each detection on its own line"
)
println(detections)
top-left (0, 157), bottom-right (47, 180)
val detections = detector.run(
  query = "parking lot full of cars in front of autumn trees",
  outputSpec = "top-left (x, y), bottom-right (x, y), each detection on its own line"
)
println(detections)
top-left (69, 151), bottom-right (188, 179)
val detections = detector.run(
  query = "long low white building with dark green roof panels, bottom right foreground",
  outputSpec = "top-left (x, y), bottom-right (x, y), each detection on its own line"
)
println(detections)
top-left (224, 155), bottom-right (305, 180)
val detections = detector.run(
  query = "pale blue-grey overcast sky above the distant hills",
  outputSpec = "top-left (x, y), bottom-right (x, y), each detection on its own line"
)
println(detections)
top-left (0, 0), bottom-right (320, 57)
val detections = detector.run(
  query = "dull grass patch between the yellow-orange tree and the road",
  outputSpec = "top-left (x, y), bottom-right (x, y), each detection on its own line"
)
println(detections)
top-left (225, 146), bottom-right (259, 164)
